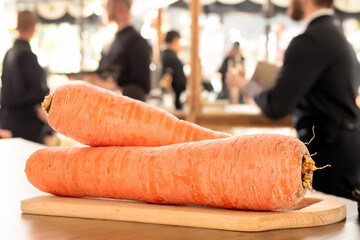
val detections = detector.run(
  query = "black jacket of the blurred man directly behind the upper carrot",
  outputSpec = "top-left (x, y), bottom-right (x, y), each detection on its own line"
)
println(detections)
top-left (98, 26), bottom-right (151, 93)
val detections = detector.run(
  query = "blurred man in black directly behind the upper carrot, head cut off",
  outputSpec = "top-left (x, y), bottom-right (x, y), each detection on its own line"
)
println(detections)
top-left (88, 0), bottom-right (151, 101)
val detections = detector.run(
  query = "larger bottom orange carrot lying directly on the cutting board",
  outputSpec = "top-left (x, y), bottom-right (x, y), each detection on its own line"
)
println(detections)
top-left (25, 134), bottom-right (314, 210)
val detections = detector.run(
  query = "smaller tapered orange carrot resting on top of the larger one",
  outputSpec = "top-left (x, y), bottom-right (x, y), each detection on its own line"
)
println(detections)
top-left (43, 83), bottom-right (230, 146)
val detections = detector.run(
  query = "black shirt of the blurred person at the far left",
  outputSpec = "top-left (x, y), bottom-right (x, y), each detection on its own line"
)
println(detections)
top-left (1, 39), bottom-right (49, 109)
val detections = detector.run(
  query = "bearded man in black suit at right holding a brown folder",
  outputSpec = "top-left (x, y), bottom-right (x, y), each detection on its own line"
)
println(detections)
top-left (228, 0), bottom-right (360, 199)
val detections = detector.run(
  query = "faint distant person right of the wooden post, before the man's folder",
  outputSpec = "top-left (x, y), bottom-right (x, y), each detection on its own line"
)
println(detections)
top-left (217, 42), bottom-right (245, 102)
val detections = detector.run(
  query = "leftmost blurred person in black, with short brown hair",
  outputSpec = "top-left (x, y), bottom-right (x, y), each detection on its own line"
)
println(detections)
top-left (1, 11), bottom-right (52, 143)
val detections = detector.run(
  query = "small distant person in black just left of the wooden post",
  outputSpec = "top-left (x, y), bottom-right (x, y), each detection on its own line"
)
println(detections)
top-left (160, 31), bottom-right (186, 110)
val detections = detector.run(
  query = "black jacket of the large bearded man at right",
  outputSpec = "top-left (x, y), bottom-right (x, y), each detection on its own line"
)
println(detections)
top-left (255, 15), bottom-right (360, 130)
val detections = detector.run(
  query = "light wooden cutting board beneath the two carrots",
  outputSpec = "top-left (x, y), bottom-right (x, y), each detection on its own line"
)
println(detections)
top-left (21, 194), bottom-right (346, 231)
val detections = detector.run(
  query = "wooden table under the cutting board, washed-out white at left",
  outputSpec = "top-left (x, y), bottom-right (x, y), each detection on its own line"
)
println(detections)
top-left (0, 138), bottom-right (360, 240)
